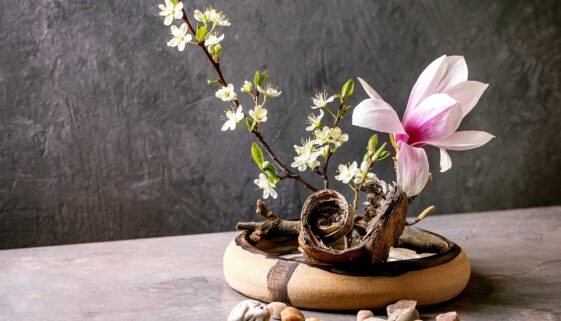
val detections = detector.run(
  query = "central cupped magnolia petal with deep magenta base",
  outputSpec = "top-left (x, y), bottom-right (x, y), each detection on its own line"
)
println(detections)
top-left (403, 94), bottom-right (462, 145)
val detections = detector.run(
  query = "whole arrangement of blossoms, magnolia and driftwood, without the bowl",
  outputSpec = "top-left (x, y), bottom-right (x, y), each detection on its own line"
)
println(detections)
top-left (155, 0), bottom-right (494, 310)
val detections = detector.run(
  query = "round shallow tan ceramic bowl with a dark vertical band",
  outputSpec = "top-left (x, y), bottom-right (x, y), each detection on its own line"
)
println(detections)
top-left (224, 227), bottom-right (471, 310)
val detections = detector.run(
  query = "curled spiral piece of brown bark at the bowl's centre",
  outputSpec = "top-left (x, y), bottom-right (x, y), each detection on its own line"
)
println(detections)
top-left (298, 180), bottom-right (408, 264)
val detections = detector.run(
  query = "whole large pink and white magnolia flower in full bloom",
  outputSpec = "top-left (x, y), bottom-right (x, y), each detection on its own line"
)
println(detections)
top-left (353, 56), bottom-right (495, 197)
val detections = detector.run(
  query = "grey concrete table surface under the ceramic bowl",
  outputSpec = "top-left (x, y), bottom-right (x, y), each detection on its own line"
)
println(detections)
top-left (0, 207), bottom-right (561, 321)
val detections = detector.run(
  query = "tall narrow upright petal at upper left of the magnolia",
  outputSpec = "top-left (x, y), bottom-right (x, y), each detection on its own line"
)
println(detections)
top-left (403, 56), bottom-right (448, 122)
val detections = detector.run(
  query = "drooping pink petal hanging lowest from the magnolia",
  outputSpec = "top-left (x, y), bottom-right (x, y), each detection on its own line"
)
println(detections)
top-left (396, 143), bottom-right (429, 197)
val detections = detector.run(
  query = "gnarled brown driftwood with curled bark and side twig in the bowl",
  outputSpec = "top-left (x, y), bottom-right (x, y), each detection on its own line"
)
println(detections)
top-left (236, 179), bottom-right (412, 264)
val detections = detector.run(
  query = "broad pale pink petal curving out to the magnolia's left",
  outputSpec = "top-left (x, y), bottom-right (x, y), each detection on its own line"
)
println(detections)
top-left (353, 99), bottom-right (405, 134)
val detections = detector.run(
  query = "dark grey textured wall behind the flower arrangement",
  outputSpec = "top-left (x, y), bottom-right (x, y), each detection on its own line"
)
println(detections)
top-left (0, 0), bottom-right (561, 248)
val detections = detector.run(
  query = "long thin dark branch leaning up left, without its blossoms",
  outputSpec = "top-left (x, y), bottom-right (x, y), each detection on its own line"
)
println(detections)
top-left (179, 0), bottom-right (318, 192)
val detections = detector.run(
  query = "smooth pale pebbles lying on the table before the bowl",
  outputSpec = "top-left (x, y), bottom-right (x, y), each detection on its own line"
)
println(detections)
top-left (228, 300), bottom-right (460, 321)
